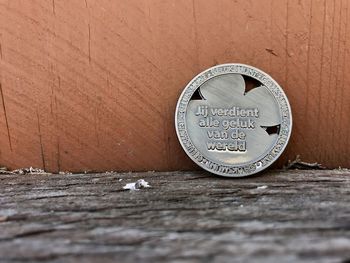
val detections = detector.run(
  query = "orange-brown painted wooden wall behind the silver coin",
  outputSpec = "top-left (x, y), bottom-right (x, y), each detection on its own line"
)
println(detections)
top-left (0, 0), bottom-right (350, 171)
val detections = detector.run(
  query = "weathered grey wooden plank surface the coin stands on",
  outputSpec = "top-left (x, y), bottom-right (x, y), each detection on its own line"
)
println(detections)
top-left (0, 171), bottom-right (350, 263)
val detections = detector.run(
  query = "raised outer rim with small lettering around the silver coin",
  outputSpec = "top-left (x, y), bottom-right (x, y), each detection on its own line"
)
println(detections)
top-left (175, 63), bottom-right (293, 177)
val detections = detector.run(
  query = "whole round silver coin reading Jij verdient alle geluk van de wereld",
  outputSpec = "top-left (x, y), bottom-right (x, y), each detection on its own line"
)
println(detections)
top-left (175, 64), bottom-right (292, 177)
